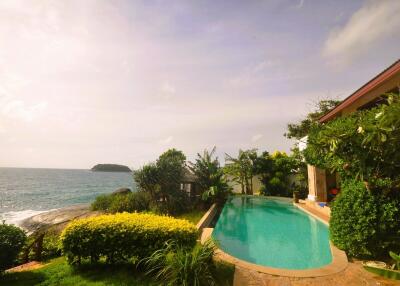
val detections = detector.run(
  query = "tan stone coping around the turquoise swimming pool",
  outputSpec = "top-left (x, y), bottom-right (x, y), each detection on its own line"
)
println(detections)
top-left (205, 196), bottom-right (348, 278)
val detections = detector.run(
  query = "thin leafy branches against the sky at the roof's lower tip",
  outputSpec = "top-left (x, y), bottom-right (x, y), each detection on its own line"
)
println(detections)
top-left (284, 99), bottom-right (340, 139)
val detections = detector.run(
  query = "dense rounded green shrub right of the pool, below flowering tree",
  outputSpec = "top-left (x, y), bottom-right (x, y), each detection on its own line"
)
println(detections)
top-left (330, 179), bottom-right (400, 258)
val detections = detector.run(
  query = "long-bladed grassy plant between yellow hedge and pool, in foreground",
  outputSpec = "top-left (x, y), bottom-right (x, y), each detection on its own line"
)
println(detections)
top-left (143, 240), bottom-right (215, 286)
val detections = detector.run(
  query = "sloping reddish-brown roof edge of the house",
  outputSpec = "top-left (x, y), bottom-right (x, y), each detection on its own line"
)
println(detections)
top-left (319, 59), bottom-right (400, 123)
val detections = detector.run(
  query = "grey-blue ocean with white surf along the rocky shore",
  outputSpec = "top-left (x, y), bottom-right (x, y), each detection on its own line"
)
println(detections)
top-left (0, 168), bottom-right (136, 225)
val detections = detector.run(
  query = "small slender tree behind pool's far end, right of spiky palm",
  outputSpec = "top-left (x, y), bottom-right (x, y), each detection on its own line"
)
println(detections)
top-left (225, 149), bottom-right (257, 195)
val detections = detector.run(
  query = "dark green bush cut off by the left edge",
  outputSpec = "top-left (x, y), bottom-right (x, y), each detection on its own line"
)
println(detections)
top-left (0, 222), bottom-right (26, 273)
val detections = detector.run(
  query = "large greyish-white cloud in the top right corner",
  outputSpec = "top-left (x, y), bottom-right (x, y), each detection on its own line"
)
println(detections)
top-left (323, 0), bottom-right (400, 63)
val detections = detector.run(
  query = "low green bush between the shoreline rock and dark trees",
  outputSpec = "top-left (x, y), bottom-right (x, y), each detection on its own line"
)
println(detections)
top-left (91, 192), bottom-right (151, 213)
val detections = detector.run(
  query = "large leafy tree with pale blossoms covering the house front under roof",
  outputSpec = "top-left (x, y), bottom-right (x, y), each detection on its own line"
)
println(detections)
top-left (304, 94), bottom-right (400, 184)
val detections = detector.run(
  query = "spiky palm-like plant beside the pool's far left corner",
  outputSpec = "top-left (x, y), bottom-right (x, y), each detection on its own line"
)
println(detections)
top-left (189, 147), bottom-right (230, 204)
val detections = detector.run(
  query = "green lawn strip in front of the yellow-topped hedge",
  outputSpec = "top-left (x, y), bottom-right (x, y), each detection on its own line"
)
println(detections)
top-left (0, 257), bottom-right (158, 286)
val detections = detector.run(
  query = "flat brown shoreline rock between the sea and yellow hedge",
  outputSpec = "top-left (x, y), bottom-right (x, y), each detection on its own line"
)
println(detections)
top-left (19, 204), bottom-right (101, 234)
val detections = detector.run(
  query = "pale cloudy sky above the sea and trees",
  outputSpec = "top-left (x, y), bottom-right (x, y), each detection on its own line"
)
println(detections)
top-left (0, 0), bottom-right (400, 168)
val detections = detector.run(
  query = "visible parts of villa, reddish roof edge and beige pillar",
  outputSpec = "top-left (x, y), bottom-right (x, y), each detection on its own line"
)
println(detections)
top-left (306, 60), bottom-right (400, 202)
